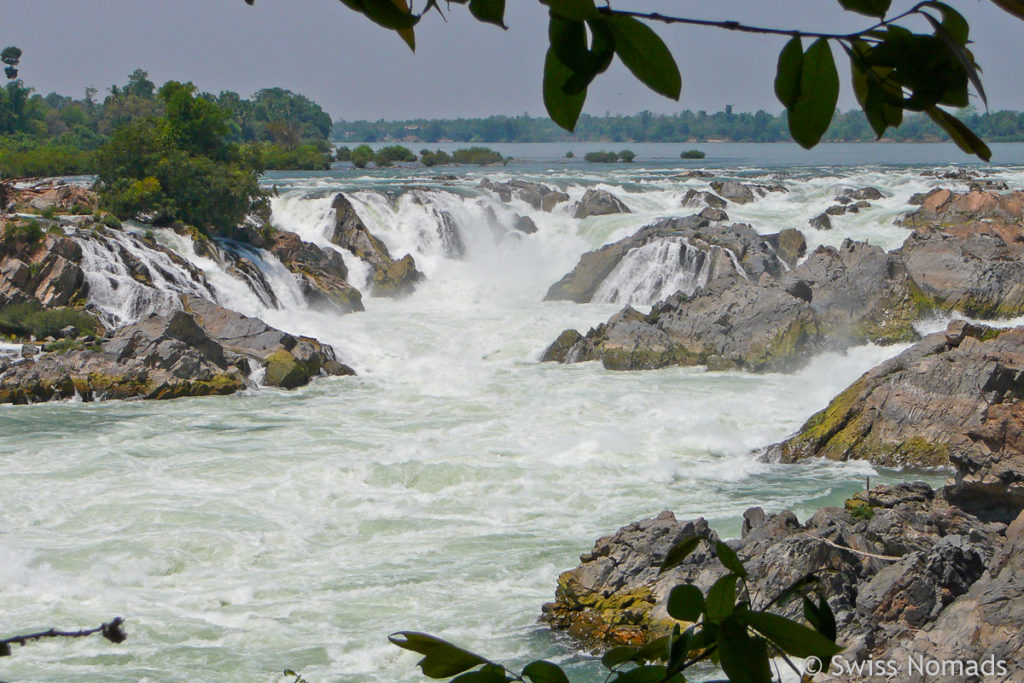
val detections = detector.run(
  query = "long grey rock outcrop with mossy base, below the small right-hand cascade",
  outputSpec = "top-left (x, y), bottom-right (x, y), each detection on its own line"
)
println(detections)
top-left (543, 240), bottom-right (930, 372)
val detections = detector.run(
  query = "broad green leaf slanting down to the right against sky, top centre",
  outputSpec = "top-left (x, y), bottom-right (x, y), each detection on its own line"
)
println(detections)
top-left (605, 14), bottom-right (683, 99)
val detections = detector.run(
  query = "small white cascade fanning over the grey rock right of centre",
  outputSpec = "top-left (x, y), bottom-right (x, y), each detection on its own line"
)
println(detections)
top-left (591, 238), bottom-right (746, 306)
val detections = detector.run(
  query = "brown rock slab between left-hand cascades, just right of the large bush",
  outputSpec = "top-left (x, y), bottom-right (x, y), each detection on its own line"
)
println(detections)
top-left (269, 230), bottom-right (364, 313)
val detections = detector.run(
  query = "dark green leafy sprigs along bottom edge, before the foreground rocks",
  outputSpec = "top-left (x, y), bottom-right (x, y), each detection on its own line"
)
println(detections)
top-left (389, 537), bottom-right (841, 683)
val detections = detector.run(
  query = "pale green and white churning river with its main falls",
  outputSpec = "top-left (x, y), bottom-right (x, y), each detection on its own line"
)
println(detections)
top-left (0, 145), bottom-right (1024, 683)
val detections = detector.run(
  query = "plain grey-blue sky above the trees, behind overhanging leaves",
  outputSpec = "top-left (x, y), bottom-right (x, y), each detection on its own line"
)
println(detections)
top-left (6, 0), bottom-right (1024, 120)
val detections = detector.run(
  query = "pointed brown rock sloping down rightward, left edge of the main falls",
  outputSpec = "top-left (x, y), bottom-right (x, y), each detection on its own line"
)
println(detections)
top-left (331, 193), bottom-right (423, 296)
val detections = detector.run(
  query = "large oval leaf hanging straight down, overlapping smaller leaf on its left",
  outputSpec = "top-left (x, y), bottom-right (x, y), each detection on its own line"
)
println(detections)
top-left (788, 38), bottom-right (839, 150)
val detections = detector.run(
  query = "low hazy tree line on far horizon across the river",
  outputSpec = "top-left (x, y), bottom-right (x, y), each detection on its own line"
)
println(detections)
top-left (331, 108), bottom-right (1024, 142)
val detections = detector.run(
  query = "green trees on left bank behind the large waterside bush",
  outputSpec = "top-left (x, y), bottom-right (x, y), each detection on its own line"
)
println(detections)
top-left (0, 47), bottom-right (332, 177)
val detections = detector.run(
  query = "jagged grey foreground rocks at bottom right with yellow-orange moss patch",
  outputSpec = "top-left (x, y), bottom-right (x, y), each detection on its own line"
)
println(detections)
top-left (542, 483), bottom-right (1011, 680)
